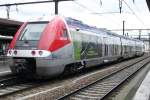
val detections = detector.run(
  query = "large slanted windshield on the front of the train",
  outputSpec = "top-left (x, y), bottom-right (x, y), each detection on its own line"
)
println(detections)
top-left (19, 22), bottom-right (47, 41)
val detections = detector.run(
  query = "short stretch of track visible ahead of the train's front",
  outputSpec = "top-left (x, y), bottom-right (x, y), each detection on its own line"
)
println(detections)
top-left (0, 75), bottom-right (35, 97)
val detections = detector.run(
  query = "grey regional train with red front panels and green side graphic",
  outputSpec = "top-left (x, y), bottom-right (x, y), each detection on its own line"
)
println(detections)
top-left (7, 16), bottom-right (144, 77)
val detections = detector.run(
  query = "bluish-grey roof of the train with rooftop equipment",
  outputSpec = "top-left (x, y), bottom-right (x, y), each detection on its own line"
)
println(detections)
top-left (65, 17), bottom-right (140, 41)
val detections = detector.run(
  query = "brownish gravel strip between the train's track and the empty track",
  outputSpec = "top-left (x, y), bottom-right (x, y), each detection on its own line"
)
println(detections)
top-left (0, 55), bottom-right (149, 100)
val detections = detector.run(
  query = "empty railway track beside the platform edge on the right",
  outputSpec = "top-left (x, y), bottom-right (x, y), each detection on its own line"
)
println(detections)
top-left (59, 57), bottom-right (150, 100)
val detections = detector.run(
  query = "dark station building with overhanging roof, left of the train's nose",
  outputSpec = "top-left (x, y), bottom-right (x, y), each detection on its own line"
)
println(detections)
top-left (0, 18), bottom-right (22, 55)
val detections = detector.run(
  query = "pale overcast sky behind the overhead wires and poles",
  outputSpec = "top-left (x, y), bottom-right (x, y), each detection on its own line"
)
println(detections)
top-left (0, 0), bottom-right (150, 36)
